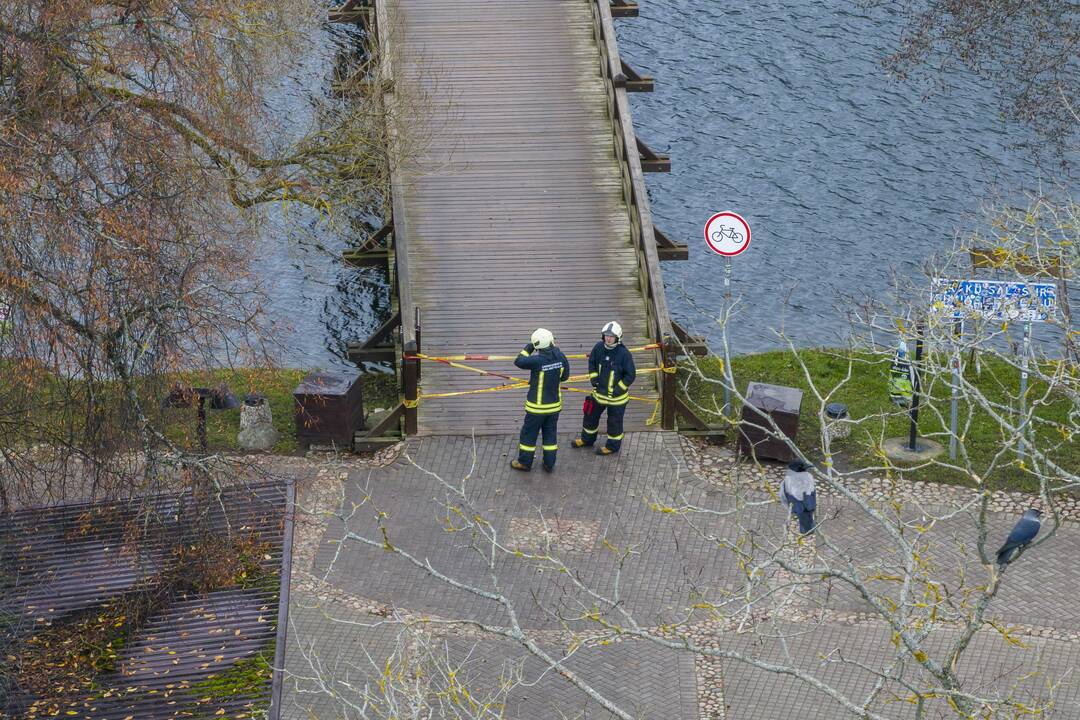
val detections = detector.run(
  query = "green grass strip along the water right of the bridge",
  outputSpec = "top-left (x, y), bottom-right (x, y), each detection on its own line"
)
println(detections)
top-left (687, 350), bottom-right (1080, 491)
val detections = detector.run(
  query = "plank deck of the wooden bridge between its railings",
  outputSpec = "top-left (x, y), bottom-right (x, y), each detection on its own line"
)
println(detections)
top-left (389, 0), bottom-right (657, 434)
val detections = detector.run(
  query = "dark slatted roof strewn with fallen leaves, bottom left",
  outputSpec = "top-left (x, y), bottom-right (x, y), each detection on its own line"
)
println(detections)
top-left (0, 483), bottom-right (293, 720)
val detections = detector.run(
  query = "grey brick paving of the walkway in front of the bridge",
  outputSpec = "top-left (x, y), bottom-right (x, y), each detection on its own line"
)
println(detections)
top-left (283, 433), bottom-right (1080, 720)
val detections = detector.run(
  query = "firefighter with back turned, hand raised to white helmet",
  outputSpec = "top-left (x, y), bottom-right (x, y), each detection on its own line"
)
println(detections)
top-left (510, 327), bottom-right (570, 473)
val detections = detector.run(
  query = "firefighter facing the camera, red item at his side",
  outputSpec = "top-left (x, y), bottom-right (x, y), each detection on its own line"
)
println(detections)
top-left (573, 322), bottom-right (636, 456)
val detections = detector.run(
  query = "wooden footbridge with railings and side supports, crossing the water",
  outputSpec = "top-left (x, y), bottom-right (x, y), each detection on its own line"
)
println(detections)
top-left (332, 0), bottom-right (708, 447)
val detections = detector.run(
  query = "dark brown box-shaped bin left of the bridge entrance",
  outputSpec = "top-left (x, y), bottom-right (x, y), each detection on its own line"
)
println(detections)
top-left (293, 370), bottom-right (364, 450)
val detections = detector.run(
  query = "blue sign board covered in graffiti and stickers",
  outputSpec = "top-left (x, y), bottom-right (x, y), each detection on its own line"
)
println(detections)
top-left (931, 277), bottom-right (1057, 323)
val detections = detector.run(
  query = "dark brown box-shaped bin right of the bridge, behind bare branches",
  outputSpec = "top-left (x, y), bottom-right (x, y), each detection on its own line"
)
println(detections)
top-left (739, 382), bottom-right (802, 462)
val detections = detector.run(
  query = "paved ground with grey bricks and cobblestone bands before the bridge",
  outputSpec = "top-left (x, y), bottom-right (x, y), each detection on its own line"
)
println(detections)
top-left (283, 433), bottom-right (1080, 720)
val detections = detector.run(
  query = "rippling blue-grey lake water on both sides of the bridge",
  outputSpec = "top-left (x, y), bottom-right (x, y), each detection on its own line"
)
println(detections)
top-left (260, 0), bottom-right (1080, 367)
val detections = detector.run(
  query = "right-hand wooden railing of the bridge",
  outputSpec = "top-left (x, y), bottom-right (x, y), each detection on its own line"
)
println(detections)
top-left (584, 0), bottom-right (675, 430)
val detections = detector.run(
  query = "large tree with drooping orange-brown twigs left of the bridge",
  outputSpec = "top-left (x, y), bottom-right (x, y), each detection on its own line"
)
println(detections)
top-left (0, 0), bottom-right (432, 508)
